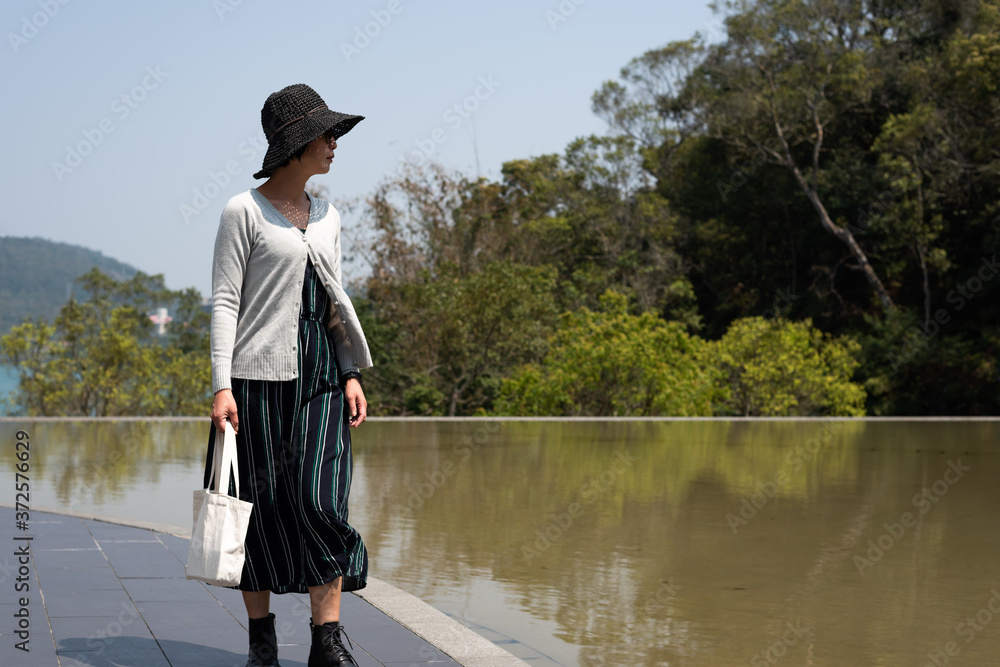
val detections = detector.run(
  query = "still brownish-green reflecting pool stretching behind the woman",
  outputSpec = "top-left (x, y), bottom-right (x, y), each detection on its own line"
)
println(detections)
top-left (0, 420), bottom-right (1000, 667)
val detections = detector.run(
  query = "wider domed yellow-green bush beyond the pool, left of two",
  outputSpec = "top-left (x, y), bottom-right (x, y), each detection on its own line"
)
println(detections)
top-left (496, 290), bottom-right (717, 416)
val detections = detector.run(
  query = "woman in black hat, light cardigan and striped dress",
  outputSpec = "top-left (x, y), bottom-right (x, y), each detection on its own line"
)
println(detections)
top-left (205, 84), bottom-right (372, 667)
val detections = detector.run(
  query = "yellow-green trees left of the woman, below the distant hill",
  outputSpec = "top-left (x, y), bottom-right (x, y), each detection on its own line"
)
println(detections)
top-left (0, 269), bottom-right (211, 416)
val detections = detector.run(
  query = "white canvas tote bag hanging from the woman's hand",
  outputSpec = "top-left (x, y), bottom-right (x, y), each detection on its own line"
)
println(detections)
top-left (184, 421), bottom-right (253, 586)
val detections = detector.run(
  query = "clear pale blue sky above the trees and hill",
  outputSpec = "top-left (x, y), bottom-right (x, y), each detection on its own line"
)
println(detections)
top-left (0, 0), bottom-right (713, 296)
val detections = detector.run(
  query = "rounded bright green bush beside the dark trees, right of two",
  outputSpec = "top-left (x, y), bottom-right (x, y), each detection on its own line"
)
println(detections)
top-left (712, 317), bottom-right (865, 417)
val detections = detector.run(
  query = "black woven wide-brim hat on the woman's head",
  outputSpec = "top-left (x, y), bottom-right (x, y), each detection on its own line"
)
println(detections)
top-left (253, 83), bottom-right (365, 178)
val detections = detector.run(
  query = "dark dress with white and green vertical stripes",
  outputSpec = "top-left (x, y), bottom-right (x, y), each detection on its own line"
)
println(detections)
top-left (204, 252), bottom-right (368, 593)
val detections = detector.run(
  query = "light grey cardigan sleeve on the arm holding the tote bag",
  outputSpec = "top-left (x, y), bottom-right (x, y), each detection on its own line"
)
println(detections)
top-left (211, 200), bottom-right (254, 393)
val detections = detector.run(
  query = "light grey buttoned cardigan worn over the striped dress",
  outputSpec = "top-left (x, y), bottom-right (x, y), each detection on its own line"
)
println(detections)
top-left (211, 189), bottom-right (372, 393)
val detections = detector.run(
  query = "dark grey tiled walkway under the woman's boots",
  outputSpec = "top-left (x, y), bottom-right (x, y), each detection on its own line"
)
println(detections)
top-left (0, 507), bottom-right (526, 667)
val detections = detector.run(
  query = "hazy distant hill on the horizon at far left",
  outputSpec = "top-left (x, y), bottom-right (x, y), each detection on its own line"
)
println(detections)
top-left (0, 236), bottom-right (136, 335)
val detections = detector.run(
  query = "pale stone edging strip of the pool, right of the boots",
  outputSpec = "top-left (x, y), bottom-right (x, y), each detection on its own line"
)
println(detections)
top-left (354, 577), bottom-right (528, 667)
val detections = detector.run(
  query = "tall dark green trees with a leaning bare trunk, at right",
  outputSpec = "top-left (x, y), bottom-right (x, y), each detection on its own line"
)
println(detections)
top-left (593, 0), bottom-right (1000, 414)
